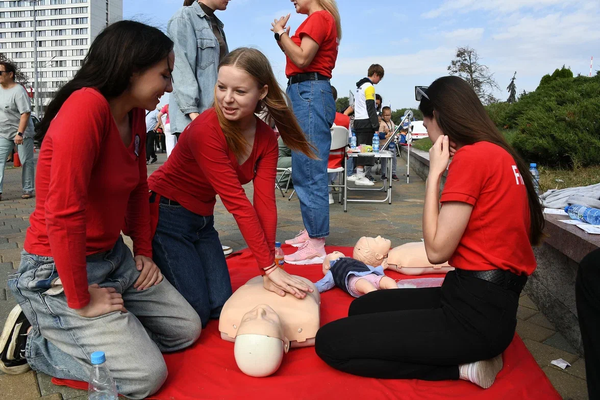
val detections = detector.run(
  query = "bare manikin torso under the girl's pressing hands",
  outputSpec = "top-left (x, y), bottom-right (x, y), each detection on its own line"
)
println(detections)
top-left (219, 276), bottom-right (321, 347)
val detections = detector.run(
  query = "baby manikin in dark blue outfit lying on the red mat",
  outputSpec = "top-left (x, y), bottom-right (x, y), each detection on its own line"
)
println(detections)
top-left (315, 251), bottom-right (398, 297)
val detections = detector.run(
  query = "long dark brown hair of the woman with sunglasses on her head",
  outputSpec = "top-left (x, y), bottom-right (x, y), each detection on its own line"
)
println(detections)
top-left (419, 76), bottom-right (544, 245)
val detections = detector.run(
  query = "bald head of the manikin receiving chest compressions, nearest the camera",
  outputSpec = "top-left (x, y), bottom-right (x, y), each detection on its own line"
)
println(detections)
top-left (234, 304), bottom-right (289, 378)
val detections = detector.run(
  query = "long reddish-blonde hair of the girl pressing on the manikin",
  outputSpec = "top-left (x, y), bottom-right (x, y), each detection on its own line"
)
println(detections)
top-left (213, 47), bottom-right (317, 159)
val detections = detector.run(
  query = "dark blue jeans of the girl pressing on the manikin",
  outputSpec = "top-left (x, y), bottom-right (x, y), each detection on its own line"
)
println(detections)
top-left (152, 197), bottom-right (232, 326)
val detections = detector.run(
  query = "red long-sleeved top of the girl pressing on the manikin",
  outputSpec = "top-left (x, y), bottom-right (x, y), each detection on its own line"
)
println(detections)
top-left (148, 108), bottom-right (279, 268)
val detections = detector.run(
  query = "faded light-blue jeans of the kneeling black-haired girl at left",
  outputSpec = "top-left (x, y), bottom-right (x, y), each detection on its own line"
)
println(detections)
top-left (8, 238), bottom-right (201, 399)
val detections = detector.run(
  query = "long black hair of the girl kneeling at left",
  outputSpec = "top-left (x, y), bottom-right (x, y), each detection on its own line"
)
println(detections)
top-left (36, 20), bottom-right (173, 141)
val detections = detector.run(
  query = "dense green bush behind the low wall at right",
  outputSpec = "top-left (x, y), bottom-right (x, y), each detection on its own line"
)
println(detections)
top-left (487, 67), bottom-right (600, 168)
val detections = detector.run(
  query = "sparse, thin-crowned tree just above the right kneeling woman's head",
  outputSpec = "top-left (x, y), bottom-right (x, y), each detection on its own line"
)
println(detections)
top-left (448, 46), bottom-right (500, 104)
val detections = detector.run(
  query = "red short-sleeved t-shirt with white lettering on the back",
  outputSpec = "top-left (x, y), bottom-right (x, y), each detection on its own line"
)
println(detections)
top-left (441, 142), bottom-right (536, 275)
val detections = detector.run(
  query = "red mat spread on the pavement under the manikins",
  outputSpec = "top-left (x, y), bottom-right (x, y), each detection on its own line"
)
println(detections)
top-left (52, 246), bottom-right (561, 400)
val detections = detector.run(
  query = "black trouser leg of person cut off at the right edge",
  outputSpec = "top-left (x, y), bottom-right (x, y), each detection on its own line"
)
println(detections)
top-left (575, 249), bottom-right (600, 400)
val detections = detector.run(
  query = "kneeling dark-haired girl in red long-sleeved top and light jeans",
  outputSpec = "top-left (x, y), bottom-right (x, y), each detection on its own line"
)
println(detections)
top-left (0, 21), bottom-right (201, 399)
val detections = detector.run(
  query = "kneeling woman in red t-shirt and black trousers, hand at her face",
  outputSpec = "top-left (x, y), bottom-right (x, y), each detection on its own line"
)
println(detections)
top-left (316, 77), bottom-right (544, 388)
